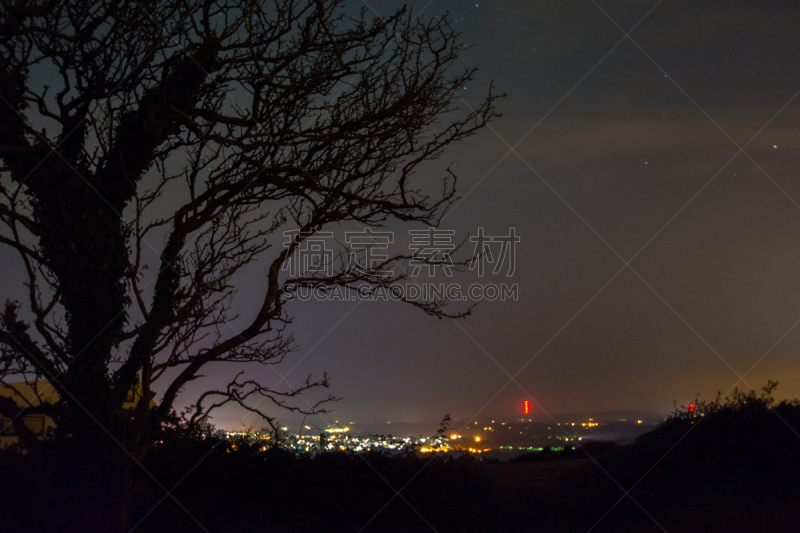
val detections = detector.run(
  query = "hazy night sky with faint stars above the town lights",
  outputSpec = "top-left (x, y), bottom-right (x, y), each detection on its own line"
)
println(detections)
top-left (0, 0), bottom-right (800, 428)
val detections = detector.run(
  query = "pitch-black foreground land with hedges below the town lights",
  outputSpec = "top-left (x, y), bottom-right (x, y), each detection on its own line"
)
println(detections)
top-left (0, 388), bottom-right (800, 533)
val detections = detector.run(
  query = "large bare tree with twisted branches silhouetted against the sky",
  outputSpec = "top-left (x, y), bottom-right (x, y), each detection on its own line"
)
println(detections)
top-left (0, 0), bottom-right (497, 520)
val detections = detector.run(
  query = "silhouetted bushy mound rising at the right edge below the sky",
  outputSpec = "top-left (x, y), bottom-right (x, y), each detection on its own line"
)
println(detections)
top-left (593, 382), bottom-right (800, 531)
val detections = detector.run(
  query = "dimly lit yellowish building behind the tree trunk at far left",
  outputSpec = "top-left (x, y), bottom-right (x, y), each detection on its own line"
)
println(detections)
top-left (0, 379), bottom-right (156, 450)
